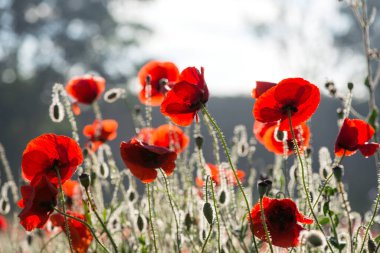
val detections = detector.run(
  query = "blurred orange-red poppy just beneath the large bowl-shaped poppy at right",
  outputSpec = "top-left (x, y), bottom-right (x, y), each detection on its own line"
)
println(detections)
top-left (253, 121), bottom-right (310, 155)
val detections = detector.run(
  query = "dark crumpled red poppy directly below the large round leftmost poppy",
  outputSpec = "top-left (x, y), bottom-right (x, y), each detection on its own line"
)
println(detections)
top-left (18, 175), bottom-right (58, 231)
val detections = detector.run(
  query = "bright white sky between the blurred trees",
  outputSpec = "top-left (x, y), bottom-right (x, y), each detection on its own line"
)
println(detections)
top-left (116, 0), bottom-right (365, 96)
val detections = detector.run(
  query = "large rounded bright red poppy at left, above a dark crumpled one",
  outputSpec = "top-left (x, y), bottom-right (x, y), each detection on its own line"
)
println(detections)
top-left (21, 134), bottom-right (83, 185)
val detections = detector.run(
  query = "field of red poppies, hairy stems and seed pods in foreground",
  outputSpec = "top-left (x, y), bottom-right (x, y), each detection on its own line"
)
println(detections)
top-left (0, 0), bottom-right (380, 253)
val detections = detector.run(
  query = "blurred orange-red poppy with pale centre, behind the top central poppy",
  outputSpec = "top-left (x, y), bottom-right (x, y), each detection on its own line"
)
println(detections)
top-left (138, 61), bottom-right (179, 106)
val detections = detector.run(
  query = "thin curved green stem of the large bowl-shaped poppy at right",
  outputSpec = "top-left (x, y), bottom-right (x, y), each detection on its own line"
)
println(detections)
top-left (288, 110), bottom-right (334, 252)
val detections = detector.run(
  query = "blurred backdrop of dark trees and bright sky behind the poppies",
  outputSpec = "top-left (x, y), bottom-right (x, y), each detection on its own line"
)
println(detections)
top-left (0, 0), bottom-right (380, 212)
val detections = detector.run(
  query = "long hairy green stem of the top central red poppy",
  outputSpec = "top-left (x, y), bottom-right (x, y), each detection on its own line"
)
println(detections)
top-left (202, 104), bottom-right (259, 252)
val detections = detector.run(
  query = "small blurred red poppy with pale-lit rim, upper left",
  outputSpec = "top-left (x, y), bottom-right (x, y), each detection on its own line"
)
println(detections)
top-left (66, 75), bottom-right (106, 105)
